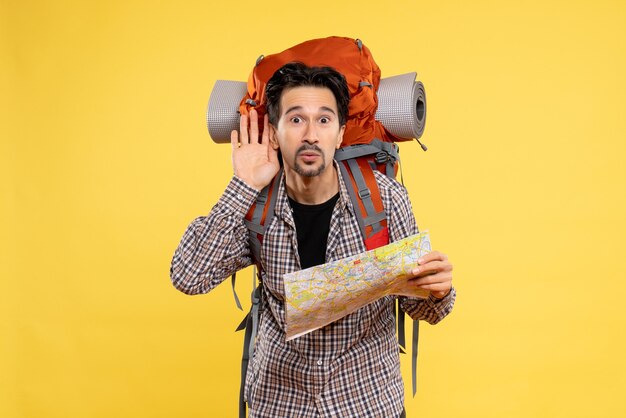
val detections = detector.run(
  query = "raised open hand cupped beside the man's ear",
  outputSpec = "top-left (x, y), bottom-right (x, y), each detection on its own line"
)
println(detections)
top-left (230, 109), bottom-right (280, 190)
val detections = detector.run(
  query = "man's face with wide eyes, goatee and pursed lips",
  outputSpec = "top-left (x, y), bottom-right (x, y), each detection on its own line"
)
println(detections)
top-left (272, 87), bottom-right (345, 177)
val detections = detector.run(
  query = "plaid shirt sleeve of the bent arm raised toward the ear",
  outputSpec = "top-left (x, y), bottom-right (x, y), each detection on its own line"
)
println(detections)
top-left (170, 177), bottom-right (259, 295)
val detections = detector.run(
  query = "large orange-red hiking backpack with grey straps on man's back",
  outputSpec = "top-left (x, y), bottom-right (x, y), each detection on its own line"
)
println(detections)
top-left (213, 37), bottom-right (426, 417)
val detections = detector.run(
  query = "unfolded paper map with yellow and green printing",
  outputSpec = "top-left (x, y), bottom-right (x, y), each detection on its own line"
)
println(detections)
top-left (283, 232), bottom-right (431, 341)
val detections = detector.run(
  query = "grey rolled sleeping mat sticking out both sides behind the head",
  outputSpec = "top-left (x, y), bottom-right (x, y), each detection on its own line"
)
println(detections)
top-left (206, 73), bottom-right (426, 144)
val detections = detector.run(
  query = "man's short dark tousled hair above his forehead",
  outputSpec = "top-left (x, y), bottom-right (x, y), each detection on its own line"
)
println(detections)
top-left (265, 62), bottom-right (350, 126)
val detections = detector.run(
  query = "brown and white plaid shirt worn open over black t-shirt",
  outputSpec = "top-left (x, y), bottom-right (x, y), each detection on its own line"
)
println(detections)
top-left (171, 164), bottom-right (456, 418)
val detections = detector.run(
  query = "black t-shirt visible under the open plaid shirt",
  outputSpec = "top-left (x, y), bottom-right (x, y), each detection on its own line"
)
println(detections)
top-left (289, 193), bottom-right (339, 269)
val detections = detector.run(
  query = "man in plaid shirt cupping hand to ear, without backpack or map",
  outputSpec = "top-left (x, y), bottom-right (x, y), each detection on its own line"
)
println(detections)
top-left (171, 63), bottom-right (455, 417)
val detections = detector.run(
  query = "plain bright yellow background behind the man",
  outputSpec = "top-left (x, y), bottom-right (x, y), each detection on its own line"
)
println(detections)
top-left (0, 0), bottom-right (626, 418)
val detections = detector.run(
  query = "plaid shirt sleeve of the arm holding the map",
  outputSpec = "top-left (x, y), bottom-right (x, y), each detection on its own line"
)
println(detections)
top-left (380, 175), bottom-right (456, 324)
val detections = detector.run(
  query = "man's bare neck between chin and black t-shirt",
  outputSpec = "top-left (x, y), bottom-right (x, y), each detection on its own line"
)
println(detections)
top-left (285, 164), bottom-right (339, 205)
